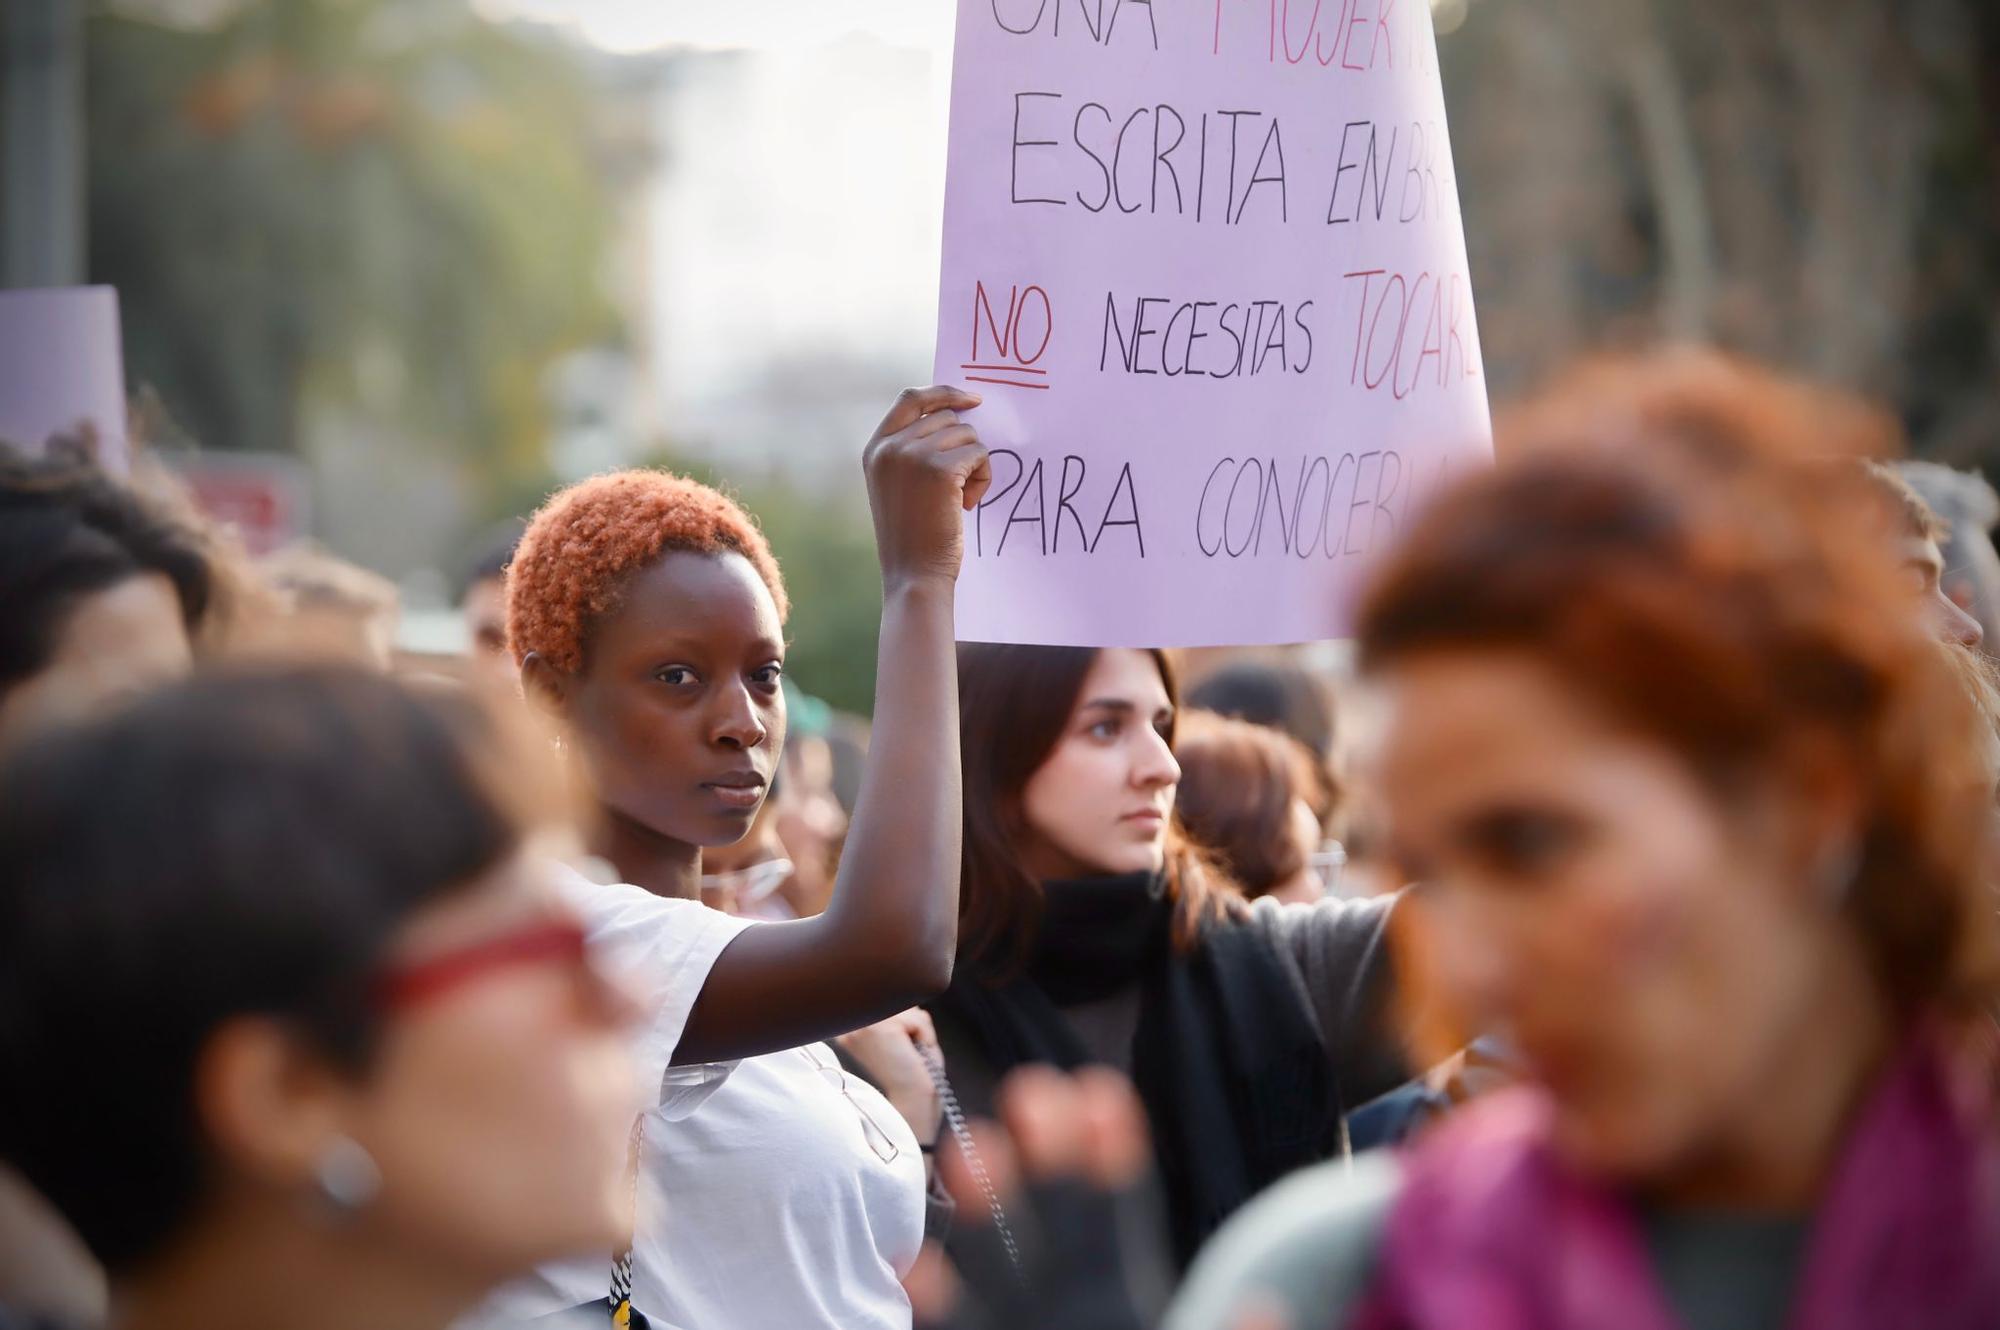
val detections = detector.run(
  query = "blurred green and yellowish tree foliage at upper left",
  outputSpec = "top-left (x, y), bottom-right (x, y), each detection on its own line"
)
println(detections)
top-left (88, 0), bottom-right (618, 504)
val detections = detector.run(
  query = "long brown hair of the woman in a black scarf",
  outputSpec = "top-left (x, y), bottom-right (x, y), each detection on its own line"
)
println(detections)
top-left (958, 642), bottom-right (1240, 972)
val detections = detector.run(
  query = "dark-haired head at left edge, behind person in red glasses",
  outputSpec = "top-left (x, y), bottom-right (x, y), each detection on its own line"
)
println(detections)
top-left (0, 448), bottom-right (212, 746)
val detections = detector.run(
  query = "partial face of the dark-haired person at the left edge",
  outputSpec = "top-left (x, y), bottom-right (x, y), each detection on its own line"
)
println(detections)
top-left (0, 572), bottom-right (194, 744)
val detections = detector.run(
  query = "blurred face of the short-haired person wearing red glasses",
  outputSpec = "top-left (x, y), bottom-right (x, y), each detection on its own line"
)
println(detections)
top-left (344, 854), bottom-right (638, 1280)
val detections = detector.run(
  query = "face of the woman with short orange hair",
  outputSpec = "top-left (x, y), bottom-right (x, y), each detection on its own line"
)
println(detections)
top-left (566, 552), bottom-right (784, 846)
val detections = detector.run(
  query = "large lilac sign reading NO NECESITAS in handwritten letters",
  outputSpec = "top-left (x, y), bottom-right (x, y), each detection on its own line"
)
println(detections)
top-left (936, 0), bottom-right (1492, 646)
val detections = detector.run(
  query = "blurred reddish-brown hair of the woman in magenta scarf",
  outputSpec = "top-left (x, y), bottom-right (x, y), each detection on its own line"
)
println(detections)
top-left (1358, 354), bottom-right (2000, 1012)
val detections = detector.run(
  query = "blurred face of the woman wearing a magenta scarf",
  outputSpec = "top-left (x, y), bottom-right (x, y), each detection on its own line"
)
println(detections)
top-left (1376, 652), bottom-right (1838, 1178)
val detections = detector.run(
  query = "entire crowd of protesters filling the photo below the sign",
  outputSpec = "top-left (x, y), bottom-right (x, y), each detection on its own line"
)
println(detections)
top-left (0, 350), bottom-right (2000, 1330)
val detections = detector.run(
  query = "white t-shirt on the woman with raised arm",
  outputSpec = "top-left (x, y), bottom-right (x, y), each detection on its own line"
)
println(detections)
top-left (476, 860), bottom-right (924, 1330)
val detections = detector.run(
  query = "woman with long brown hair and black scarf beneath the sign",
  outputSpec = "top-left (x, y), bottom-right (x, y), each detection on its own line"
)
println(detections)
top-left (932, 646), bottom-right (1406, 1326)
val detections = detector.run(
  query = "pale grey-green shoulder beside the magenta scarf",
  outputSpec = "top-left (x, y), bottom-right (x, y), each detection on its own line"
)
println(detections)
top-left (1162, 1154), bottom-right (1402, 1330)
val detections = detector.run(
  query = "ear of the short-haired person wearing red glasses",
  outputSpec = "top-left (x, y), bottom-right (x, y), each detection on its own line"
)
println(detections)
top-left (194, 1016), bottom-right (352, 1188)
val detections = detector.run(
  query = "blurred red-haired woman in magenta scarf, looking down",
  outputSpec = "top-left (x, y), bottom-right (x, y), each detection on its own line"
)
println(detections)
top-left (1168, 356), bottom-right (2000, 1330)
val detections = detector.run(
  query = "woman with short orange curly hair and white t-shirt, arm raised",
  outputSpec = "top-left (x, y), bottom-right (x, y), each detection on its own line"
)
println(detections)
top-left (476, 388), bottom-right (990, 1330)
